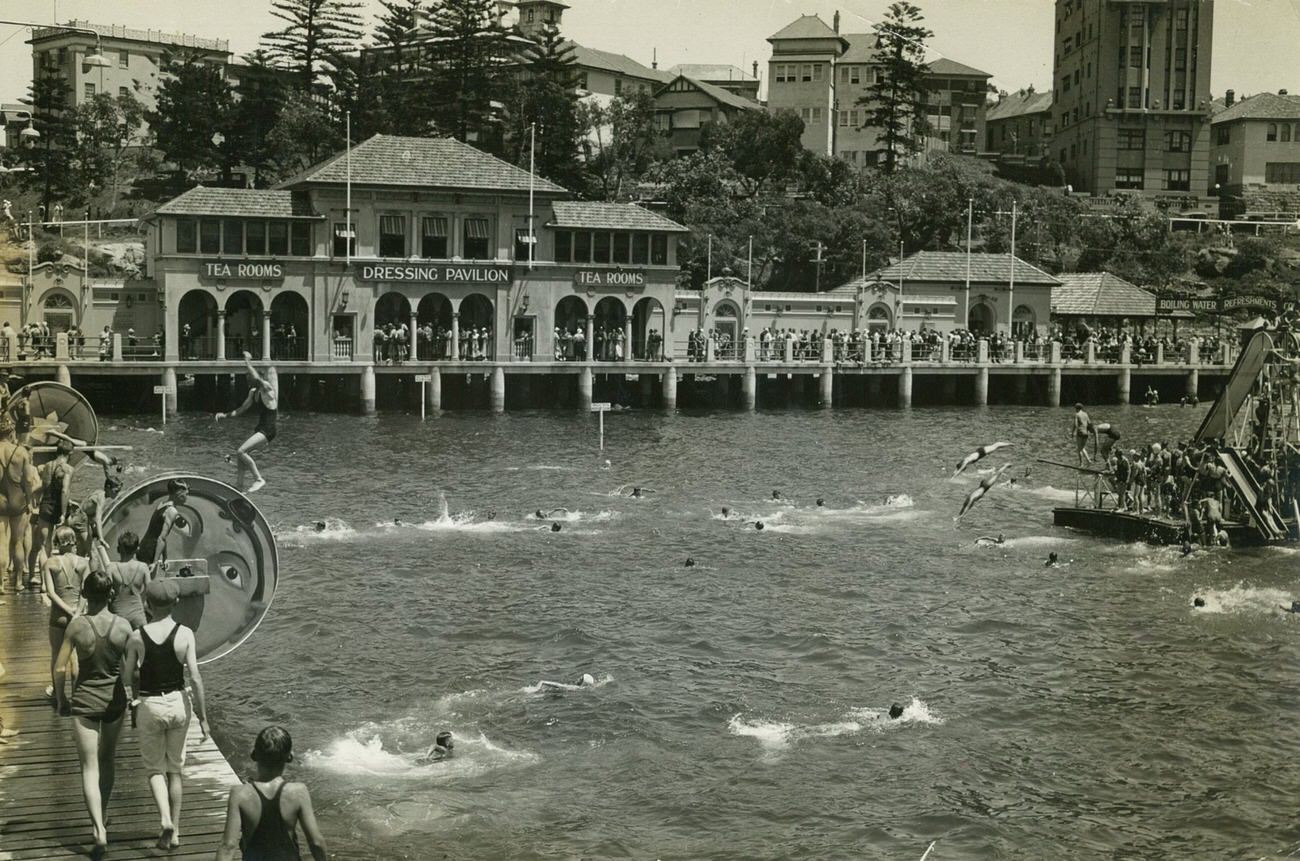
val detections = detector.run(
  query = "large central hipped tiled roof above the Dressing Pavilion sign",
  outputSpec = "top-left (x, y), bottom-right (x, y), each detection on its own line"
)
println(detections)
top-left (276, 134), bottom-right (564, 194)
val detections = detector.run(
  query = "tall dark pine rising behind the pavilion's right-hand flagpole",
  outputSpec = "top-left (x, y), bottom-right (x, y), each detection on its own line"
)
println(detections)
top-left (508, 25), bottom-right (582, 189)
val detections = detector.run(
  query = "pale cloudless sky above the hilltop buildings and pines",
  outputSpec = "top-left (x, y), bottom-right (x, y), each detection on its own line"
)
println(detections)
top-left (0, 0), bottom-right (1300, 101)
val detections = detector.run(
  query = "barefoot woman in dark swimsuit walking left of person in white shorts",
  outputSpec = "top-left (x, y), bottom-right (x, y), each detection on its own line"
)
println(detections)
top-left (53, 571), bottom-right (131, 858)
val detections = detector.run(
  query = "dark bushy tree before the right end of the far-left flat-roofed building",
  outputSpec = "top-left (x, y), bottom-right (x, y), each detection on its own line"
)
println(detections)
top-left (146, 53), bottom-right (235, 176)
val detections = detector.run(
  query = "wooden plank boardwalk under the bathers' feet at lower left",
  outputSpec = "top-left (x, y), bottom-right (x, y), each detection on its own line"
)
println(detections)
top-left (0, 592), bottom-right (239, 861)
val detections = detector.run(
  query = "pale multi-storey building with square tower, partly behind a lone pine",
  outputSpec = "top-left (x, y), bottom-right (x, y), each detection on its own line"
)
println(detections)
top-left (767, 14), bottom-right (989, 164)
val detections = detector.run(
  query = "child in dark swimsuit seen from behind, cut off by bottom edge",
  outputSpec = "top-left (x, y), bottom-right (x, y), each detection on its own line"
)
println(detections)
top-left (217, 727), bottom-right (326, 861)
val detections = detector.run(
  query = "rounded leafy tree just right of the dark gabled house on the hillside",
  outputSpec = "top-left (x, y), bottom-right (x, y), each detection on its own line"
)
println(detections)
top-left (701, 111), bottom-right (805, 196)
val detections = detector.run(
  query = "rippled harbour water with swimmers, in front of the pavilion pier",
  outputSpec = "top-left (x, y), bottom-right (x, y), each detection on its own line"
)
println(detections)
top-left (91, 406), bottom-right (1300, 861)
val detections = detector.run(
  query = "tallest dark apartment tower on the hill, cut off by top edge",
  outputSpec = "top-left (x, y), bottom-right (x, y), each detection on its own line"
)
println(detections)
top-left (1052, 0), bottom-right (1214, 194)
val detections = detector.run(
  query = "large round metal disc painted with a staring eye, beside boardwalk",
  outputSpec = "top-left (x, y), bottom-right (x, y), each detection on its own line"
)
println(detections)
top-left (104, 472), bottom-right (280, 663)
